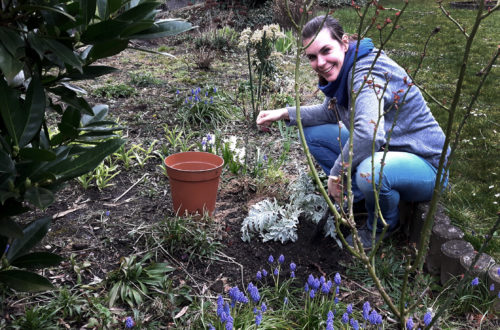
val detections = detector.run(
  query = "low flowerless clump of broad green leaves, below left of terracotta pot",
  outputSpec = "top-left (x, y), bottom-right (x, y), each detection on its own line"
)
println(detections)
top-left (107, 253), bottom-right (175, 307)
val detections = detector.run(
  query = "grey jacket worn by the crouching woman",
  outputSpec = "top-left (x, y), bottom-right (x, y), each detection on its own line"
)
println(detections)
top-left (287, 49), bottom-right (449, 176)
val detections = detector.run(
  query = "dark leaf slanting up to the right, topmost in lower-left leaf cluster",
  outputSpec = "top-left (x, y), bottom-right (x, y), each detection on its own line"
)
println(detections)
top-left (7, 217), bottom-right (51, 262)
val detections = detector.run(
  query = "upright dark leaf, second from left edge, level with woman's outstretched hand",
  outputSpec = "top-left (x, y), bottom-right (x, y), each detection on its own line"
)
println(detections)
top-left (15, 75), bottom-right (45, 147)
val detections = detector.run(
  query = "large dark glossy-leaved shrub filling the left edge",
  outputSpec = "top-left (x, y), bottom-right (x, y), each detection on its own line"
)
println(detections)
top-left (0, 0), bottom-right (192, 291)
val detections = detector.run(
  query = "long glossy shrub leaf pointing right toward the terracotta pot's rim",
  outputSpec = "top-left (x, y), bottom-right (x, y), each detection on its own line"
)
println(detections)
top-left (51, 139), bottom-right (125, 182)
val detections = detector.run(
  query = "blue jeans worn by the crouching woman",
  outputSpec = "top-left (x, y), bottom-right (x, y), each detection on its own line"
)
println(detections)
top-left (304, 124), bottom-right (446, 231)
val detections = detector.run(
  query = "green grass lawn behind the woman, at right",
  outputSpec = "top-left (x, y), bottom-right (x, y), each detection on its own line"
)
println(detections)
top-left (335, 0), bottom-right (500, 261)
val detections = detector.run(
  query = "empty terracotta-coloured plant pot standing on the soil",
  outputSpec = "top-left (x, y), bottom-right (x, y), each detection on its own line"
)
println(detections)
top-left (165, 151), bottom-right (224, 216)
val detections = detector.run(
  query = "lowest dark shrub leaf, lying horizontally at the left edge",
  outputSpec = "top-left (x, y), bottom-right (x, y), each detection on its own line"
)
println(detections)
top-left (0, 270), bottom-right (54, 292)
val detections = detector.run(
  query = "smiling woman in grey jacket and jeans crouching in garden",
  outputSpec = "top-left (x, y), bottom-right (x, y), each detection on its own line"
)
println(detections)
top-left (257, 16), bottom-right (445, 249)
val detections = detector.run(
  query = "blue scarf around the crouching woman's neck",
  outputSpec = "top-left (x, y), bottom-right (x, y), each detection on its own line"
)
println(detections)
top-left (318, 38), bottom-right (374, 108)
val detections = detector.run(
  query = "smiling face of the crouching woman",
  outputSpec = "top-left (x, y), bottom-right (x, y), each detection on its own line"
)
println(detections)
top-left (303, 28), bottom-right (349, 82)
